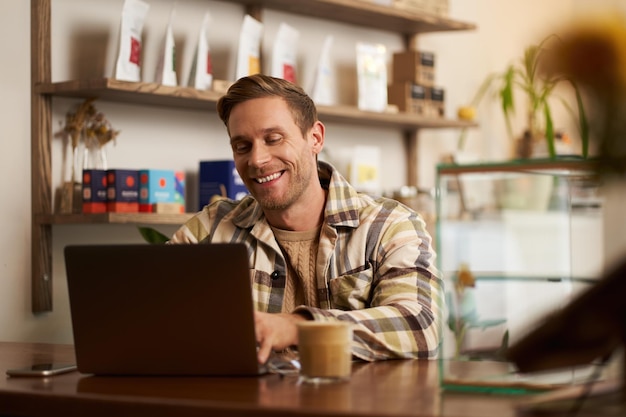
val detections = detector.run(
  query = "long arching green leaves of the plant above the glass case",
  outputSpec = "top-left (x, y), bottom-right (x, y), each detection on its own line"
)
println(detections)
top-left (458, 35), bottom-right (589, 158)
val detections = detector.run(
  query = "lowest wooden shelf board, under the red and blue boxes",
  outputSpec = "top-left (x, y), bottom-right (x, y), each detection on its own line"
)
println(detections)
top-left (35, 213), bottom-right (195, 225)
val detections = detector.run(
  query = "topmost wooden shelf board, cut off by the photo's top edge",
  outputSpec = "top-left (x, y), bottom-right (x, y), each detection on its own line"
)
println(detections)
top-left (227, 0), bottom-right (476, 35)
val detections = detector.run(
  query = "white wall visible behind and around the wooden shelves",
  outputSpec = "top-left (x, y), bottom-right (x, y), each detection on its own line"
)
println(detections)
top-left (0, 0), bottom-right (608, 342)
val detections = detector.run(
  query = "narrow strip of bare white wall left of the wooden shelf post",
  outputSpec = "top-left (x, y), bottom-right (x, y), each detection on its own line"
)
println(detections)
top-left (0, 1), bottom-right (33, 340)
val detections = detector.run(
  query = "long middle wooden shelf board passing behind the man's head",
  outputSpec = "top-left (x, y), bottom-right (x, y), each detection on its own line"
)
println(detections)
top-left (35, 78), bottom-right (476, 130)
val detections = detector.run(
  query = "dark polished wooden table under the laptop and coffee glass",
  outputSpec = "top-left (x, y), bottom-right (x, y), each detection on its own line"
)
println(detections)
top-left (0, 342), bottom-right (522, 417)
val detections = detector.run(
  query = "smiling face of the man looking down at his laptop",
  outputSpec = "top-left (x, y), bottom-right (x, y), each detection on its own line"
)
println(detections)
top-left (228, 97), bottom-right (324, 210)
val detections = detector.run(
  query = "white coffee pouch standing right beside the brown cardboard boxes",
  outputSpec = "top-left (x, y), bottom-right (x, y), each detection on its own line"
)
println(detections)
top-left (356, 42), bottom-right (387, 112)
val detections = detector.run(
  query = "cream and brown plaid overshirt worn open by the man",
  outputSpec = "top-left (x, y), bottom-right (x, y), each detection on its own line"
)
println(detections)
top-left (170, 162), bottom-right (444, 361)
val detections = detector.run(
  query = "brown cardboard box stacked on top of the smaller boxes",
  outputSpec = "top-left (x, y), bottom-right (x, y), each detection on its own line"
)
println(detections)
top-left (392, 51), bottom-right (435, 87)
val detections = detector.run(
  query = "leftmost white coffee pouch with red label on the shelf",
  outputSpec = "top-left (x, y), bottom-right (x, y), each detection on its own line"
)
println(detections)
top-left (115, 0), bottom-right (150, 81)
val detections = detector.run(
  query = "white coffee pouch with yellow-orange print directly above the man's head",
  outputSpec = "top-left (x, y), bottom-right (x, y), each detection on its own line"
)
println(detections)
top-left (235, 15), bottom-right (263, 80)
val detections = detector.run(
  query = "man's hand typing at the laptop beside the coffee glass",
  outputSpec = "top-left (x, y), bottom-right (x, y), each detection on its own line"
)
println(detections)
top-left (254, 311), bottom-right (306, 363)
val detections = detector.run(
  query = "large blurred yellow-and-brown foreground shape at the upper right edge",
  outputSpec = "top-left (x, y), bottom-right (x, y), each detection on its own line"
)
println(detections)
top-left (543, 11), bottom-right (626, 177)
